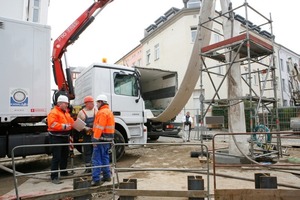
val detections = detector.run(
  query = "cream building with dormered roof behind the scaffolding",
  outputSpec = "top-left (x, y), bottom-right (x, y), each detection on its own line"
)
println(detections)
top-left (116, 0), bottom-right (300, 122)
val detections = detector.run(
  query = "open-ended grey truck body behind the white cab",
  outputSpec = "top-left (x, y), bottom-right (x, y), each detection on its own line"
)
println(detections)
top-left (135, 67), bottom-right (181, 140)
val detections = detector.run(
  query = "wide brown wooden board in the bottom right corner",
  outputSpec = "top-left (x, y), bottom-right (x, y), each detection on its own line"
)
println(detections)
top-left (215, 189), bottom-right (300, 200)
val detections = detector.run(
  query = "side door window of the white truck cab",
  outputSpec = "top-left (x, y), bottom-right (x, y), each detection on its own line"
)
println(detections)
top-left (114, 73), bottom-right (138, 97)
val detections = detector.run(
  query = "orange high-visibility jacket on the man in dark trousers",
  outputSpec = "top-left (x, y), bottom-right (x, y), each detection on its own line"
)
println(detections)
top-left (47, 106), bottom-right (74, 133)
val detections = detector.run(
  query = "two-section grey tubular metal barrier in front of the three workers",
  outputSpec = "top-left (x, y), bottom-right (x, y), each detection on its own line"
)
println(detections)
top-left (11, 142), bottom-right (210, 200)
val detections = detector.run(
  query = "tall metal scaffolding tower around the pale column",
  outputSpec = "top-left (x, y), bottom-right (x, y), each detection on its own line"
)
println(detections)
top-left (199, 1), bottom-right (281, 158)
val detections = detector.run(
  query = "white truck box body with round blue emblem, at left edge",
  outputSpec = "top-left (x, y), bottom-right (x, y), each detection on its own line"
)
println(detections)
top-left (0, 17), bottom-right (51, 157)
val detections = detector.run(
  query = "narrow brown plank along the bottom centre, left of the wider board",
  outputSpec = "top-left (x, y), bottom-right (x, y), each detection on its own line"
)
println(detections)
top-left (115, 189), bottom-right (208, 197)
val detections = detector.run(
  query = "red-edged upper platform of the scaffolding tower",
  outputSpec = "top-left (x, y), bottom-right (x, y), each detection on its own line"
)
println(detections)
top-left (201, 33), bottom-right (273, 62)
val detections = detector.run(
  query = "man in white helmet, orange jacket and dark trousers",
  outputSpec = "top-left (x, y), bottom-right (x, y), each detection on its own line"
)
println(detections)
top-left (47, 95), bottom-right (74, 184)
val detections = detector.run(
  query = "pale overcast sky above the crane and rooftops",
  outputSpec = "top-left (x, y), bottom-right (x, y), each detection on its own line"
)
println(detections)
top-left (48, 0), bottom-right (300, 67)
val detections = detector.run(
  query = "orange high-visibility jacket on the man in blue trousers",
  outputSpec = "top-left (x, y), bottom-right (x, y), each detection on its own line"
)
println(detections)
top-left (93, 105), bottom-right (115, 141)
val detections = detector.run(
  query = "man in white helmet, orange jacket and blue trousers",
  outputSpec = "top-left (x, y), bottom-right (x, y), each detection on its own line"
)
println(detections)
top-left (91, 94), bottom-right (115, 186)
